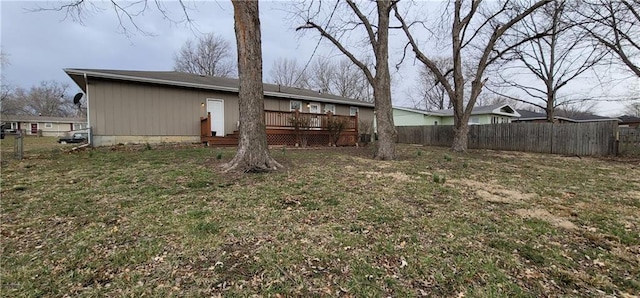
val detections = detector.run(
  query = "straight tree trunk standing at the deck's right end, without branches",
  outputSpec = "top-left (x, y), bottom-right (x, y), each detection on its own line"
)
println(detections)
top-left (373, 1), bottom-right (397, 160)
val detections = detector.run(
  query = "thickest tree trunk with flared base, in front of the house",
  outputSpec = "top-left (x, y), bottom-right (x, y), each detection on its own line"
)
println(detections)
top-left (223, 0), bottom-right (282, 172)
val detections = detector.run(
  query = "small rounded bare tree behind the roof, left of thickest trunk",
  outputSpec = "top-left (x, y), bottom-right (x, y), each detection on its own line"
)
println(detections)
top-left (173, 33), bottom-right (235, 77)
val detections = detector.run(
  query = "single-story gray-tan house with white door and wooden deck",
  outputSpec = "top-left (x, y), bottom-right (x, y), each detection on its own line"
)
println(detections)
top-left (64, 69), bottom-right (374, 146)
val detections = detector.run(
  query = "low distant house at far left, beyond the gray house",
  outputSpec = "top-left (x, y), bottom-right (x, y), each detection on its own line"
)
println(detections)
top-left (0, 115), bottom-right (87, 137)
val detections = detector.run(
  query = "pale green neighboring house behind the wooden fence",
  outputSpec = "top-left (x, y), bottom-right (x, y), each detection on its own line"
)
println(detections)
top-left (393, 104), bottom-right (520, 126)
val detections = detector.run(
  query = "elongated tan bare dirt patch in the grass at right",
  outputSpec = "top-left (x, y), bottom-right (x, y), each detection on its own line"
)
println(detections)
top-left (451, 179), bottom-right (537, 204)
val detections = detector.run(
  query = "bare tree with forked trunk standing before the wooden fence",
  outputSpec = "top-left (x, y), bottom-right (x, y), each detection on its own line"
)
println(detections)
top-left (394, 0), bottom-right (552, 152)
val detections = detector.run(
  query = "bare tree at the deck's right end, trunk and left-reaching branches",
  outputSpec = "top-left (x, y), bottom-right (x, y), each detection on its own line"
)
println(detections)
top-left (296, 0), bottom-right (397, 160)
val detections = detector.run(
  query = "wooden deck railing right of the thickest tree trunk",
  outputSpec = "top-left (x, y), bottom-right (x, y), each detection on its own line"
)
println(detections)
top-left (264, 110), bottom-right (358, 132)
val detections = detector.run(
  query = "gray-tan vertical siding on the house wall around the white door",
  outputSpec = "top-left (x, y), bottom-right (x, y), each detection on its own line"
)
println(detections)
top-left (89, 78), bottom-right (373, 141)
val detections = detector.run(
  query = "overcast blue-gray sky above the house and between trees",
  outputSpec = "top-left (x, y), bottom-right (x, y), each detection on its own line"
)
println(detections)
top-left (0, 1), bottom-right (640, 115)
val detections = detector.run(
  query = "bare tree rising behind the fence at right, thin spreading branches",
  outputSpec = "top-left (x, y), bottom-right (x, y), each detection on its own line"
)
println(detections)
top-left (498, 1), bottom-right (607, 122)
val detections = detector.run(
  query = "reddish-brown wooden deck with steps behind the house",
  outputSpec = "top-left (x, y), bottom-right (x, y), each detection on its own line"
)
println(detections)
top-left (200, 111), bottom-right (358, 147)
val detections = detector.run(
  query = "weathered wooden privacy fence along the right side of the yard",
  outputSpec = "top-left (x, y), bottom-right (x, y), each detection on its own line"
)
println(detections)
top-left (396, 121), bottom-right (618, 156)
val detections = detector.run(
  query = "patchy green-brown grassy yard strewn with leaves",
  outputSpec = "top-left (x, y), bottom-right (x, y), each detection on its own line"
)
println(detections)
top-left (0, 138), bottom-right (640, 297)
